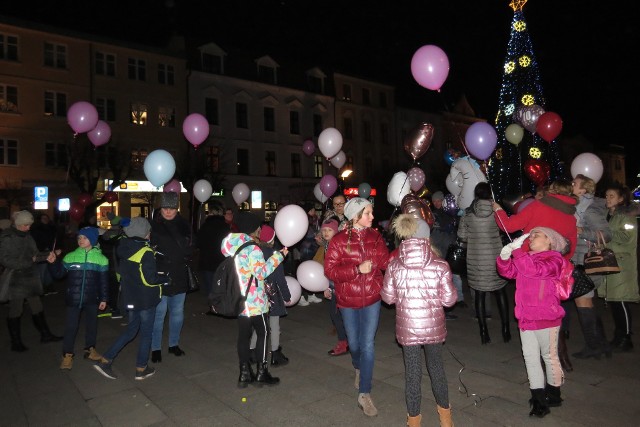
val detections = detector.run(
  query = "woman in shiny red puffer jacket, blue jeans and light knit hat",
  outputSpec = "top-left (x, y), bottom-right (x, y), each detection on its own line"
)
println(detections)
top-left (324, 197), bottom-right (389, 417)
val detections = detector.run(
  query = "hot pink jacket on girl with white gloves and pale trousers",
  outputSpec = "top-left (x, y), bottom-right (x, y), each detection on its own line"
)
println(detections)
top-left (497, 248), bottom-right (569, 331)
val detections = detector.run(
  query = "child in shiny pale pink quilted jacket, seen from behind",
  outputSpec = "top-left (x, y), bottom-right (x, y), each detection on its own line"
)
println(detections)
top-left (380, 214), bottom-right (458, 426)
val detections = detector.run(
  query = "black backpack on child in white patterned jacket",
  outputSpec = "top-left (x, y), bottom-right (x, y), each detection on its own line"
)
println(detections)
top-left (209, 242), bottom-right (255, 317)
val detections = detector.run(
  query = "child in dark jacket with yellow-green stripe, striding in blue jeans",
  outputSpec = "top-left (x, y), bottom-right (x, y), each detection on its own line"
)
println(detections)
top-left (94, 217), bottom-right (166, 380)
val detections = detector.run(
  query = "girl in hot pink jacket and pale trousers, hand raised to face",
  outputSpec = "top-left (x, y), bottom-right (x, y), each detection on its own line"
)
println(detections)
top-left (497, 227), bottom-right (571, 418)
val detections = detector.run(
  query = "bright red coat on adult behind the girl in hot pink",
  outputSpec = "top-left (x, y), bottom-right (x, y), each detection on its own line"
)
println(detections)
top-left (496, 194), bottom-right (578, 259)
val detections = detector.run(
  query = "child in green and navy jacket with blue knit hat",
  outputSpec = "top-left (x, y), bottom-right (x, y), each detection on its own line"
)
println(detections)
top-left (56, 227), bottom-right (109, 369)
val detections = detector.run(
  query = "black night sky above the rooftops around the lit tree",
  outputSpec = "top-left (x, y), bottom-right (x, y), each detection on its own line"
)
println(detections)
top-left (5, 0), bottom-right (640, 187)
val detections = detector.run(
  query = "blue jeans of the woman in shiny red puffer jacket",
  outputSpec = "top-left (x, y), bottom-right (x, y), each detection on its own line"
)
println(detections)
top-left (340, 301), bottom-right (380, 393)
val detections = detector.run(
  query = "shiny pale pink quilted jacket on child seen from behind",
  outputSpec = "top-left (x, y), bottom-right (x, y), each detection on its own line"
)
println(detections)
top-left (380, 239), bottom-right (458, 346)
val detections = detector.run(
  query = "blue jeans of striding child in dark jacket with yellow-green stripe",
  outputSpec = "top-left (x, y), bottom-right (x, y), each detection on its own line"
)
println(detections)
top-left (102, 307), bottom-right (156, 368)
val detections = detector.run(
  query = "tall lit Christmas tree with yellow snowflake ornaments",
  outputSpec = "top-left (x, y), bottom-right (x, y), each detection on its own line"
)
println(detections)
top-left (488, 0), bottom-right (564, 200)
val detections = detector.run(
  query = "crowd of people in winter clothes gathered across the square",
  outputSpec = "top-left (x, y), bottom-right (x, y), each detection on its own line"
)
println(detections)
top-left (0, 175), bottom-right (640, 426)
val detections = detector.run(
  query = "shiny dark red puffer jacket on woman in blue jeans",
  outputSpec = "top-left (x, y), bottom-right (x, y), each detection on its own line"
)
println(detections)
top-left (324, 228), bottom-right (389, 308)
